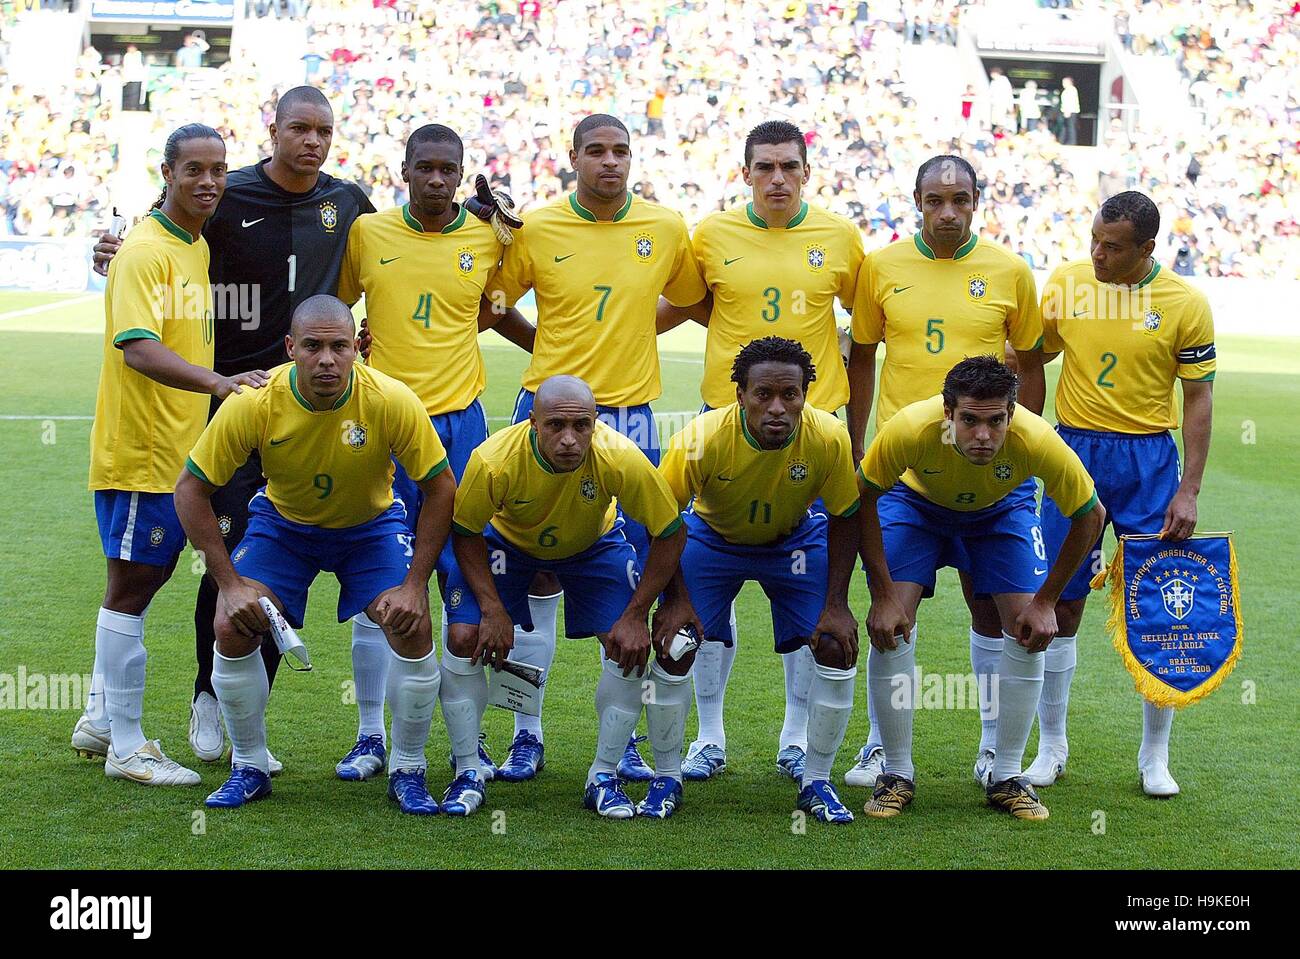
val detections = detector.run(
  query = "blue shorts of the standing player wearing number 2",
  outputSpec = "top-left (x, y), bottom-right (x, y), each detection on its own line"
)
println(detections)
top-left (1043, 426), bottom-right (1183, 599)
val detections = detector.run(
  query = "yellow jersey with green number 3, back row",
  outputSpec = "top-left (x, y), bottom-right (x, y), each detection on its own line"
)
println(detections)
top-left (693, 203), bottom-right (862, 412)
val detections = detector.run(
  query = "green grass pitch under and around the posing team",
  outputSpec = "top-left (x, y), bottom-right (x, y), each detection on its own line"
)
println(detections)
top-left (0, 294), bottom-right (1300, 868)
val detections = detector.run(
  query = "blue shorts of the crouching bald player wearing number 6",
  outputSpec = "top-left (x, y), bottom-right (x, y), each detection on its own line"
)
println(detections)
top-left (446, 518), bottom-right (640, 639)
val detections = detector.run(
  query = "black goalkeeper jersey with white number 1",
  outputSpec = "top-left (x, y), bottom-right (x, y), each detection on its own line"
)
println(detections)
top-left (203, 160), bottom-right (374, 376)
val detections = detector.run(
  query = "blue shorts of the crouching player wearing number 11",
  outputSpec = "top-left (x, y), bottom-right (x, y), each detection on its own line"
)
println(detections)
top-left (681, 511), bottom-right (827, 652)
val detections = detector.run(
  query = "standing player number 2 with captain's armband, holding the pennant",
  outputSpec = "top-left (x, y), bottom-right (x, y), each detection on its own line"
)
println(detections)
top-left (1026, 191), bottom-right (1216, 797)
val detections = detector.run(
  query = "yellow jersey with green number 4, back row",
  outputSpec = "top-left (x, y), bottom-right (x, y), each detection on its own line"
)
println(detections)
top-left (338, 204), bottom-right (502, 416)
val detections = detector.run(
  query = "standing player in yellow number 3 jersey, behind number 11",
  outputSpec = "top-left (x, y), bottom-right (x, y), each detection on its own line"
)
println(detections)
top-left (660, 120), bottom-right (862, 781)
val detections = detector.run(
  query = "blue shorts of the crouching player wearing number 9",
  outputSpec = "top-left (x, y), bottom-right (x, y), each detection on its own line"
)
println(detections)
top-left (230, 490), bottom-right (413, 629)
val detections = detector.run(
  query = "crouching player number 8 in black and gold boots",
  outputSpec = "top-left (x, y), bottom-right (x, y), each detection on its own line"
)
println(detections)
top-left (858, 355), bottom-right (1106, 819)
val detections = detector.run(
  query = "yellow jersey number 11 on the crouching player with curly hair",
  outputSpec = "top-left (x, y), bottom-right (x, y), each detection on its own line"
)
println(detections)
top-left (659, 403), bottom-right (858, 546)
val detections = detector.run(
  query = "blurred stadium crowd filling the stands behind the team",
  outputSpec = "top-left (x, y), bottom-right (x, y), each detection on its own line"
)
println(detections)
top-left (0, 0), bottom-right (1300, 278)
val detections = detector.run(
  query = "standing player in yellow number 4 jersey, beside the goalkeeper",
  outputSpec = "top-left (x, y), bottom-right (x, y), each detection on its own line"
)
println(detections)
top-left (338, 123), bottom-right (533, 780)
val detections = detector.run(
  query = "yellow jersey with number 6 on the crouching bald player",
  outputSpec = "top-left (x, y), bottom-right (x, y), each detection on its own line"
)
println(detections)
top-left (451, 421), bottom-right (681, 559)
